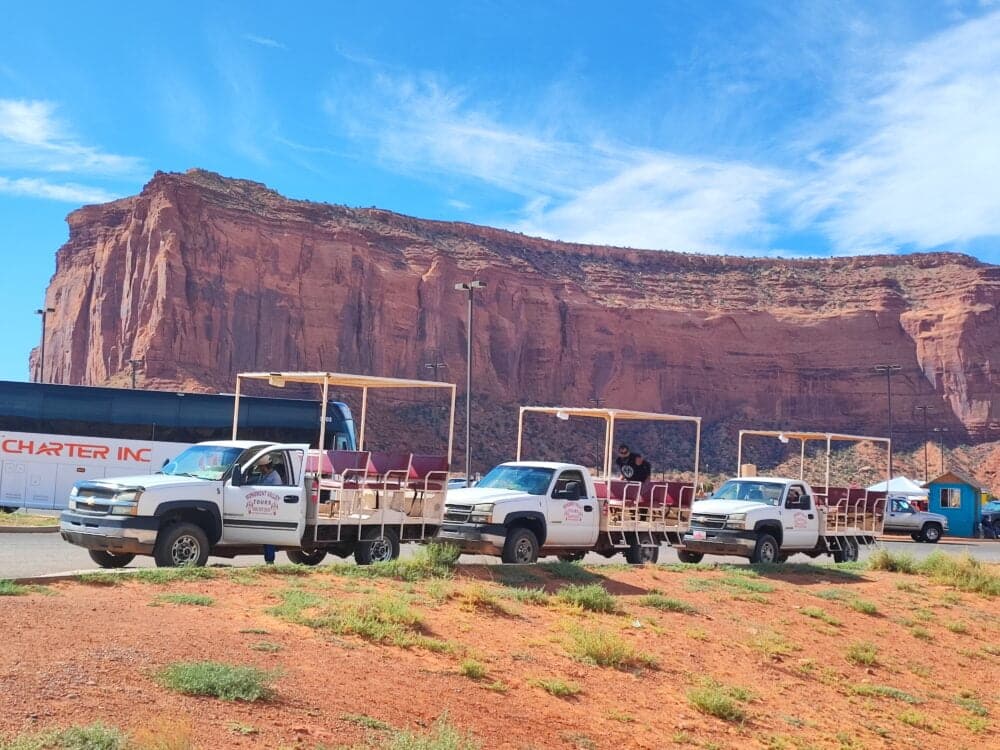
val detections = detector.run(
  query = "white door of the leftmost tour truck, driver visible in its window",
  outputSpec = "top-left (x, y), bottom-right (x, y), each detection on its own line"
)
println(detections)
top-left (222, 445), bottom-right (309, 547)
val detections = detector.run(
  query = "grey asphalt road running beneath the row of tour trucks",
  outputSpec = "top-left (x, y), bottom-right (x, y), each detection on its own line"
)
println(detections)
top-left (0, 533), bottom-right (1000, 578)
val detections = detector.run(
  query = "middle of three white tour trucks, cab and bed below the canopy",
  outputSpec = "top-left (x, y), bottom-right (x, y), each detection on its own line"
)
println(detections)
top-left (438, 461), bottom-right (682, 565)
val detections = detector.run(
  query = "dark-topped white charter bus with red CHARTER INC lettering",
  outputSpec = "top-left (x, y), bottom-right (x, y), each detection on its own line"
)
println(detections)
top-left (0, 381), bottom-right (355, 512)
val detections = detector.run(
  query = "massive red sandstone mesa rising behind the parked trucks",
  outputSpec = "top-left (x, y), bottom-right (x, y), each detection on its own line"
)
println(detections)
top-left (36, 170), bottom-right (1000, 472)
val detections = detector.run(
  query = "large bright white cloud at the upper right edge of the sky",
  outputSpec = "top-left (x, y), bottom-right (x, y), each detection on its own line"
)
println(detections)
top-left (793, 13), bottom-right (1000, 253)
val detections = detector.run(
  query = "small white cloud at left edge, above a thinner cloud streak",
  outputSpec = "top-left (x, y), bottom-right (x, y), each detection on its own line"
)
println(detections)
top-left (0, 99), bottom-right (142, 176)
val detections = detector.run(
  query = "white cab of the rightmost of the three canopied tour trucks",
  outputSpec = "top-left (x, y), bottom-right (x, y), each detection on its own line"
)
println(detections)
top-left (679, 477), bottom-right (821, 563)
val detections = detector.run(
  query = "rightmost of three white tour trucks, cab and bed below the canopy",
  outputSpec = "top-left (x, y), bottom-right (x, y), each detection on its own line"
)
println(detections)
top-left (678, 477), bottom-right (885, 563)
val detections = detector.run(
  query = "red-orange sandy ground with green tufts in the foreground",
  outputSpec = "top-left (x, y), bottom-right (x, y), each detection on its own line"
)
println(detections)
top-left (0, 566), bottom-right (1000, 750)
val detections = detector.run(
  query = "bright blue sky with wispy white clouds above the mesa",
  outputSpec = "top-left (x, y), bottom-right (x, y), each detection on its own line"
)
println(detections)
top-left (0, 0), bottom-right (1000, 380)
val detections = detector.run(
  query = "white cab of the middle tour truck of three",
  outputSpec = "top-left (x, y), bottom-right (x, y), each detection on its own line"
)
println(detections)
top-left (438, 461), bottom-right (601, 563)
